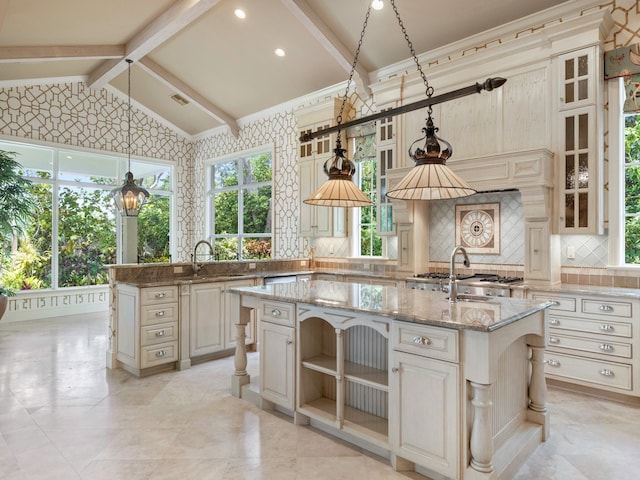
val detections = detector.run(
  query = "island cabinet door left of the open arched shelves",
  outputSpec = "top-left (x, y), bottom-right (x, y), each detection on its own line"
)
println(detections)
top-left (259, 321), bottom-right (295, 410)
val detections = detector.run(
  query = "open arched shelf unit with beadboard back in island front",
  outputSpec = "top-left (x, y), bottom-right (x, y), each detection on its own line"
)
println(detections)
top-left (296, 305), bottom-right (389, 448)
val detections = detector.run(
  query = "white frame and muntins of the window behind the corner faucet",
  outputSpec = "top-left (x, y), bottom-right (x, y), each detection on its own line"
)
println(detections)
top-left (204, 144), bottom-right (276, 260)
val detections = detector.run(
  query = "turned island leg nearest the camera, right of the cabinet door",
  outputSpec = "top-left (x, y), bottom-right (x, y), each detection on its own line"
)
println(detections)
top-left (469, 382), bottom-right (493, 473)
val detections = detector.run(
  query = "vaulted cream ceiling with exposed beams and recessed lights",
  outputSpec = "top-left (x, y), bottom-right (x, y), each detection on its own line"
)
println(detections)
top-left (0, 0), bottom-right (575, 136)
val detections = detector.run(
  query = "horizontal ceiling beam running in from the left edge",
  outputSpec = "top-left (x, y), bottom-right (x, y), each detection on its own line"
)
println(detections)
top-left (0, 45), bottom-right (125, 63)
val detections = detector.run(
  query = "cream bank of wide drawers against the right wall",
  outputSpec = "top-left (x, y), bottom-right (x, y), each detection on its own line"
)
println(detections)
top-left (531, 292), bottom-right (640, 396)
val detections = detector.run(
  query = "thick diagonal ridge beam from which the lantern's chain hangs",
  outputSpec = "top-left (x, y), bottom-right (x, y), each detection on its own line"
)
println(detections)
top-left (87, 0), bottom-right (220, 88)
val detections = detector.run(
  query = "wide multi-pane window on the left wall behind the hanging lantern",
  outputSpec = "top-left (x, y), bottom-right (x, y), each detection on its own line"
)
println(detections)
top-left (0, 138), bottom-right (172, 290)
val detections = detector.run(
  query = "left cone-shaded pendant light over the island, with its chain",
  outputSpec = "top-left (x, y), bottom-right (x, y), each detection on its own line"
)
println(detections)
top-left (304, 4), bottom-right (373, 207)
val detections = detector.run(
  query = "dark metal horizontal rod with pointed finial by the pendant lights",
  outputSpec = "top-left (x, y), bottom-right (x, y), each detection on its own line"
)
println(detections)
top-left (300, 77), bottom-right (507, 142)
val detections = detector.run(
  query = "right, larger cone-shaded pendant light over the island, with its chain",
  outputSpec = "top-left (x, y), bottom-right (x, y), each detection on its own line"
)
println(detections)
top-left (387, 0), bottom-right (476, 200)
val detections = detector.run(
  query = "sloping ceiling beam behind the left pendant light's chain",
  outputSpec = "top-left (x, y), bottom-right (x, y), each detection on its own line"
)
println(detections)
top-left (281, 0), bottom-right (371, 100)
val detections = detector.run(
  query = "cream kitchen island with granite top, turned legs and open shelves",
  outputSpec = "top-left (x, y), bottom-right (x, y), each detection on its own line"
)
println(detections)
top-left (231, 281), bottom-right (551, 479)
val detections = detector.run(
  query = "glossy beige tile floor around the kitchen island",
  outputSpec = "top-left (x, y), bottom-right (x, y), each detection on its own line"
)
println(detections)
top-left (0, 315), bottom-right (640, 480)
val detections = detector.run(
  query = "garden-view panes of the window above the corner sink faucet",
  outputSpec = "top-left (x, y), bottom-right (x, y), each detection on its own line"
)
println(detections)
top-left (207, 151), bottom-right (273, 260)
